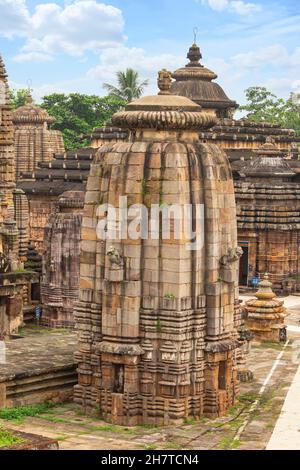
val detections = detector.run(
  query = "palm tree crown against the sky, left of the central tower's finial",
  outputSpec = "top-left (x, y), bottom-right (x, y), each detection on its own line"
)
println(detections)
top-left (103, 68), bottom-right (149, 101)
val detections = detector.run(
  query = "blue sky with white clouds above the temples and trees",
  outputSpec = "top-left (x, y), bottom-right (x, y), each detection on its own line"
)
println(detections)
top-left (0, 0), bottom-right (300, 103)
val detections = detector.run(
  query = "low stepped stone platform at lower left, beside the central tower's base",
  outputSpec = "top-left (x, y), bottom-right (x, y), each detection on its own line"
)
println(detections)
top-left (0, 326), bottom-right (77, 407)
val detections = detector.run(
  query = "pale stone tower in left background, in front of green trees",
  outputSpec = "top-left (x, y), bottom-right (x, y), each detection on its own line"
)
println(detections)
top-left (13, 91), bottom-right (64, 178)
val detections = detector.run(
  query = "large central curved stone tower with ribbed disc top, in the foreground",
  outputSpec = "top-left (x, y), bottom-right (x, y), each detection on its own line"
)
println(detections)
top-left (75, 70), bottom-right (240, 425)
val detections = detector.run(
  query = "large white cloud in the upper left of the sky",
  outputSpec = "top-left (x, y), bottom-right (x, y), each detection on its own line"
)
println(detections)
top-left (0, 0), bottom-right (125, 62)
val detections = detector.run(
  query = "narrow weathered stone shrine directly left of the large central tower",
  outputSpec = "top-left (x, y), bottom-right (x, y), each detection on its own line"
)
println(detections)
top-left (41, 191), bottom-right (84, 327)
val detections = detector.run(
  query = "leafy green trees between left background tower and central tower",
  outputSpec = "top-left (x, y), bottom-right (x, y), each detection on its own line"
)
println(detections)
top-left (41, 93), bottom-right (126, 150)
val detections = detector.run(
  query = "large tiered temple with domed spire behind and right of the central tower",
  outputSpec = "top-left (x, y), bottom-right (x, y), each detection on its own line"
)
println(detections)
top-left (171, 44), bottom-right (300, 289)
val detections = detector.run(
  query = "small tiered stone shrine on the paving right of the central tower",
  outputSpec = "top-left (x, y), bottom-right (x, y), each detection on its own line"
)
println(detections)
top-left (245, 274), bottom-right (287, 343)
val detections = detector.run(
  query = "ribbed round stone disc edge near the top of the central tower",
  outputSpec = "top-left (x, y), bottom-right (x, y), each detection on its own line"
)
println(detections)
top-left (112, 110), bottom-right (216, 130)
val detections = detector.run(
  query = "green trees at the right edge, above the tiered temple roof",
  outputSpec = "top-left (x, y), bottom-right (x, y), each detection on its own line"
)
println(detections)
top-left (240, 87), bottom-right (300, 135)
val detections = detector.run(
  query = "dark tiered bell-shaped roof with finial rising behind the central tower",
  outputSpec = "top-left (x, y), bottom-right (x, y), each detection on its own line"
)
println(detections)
top-left (171, 44), bottom-right (238, 118)
